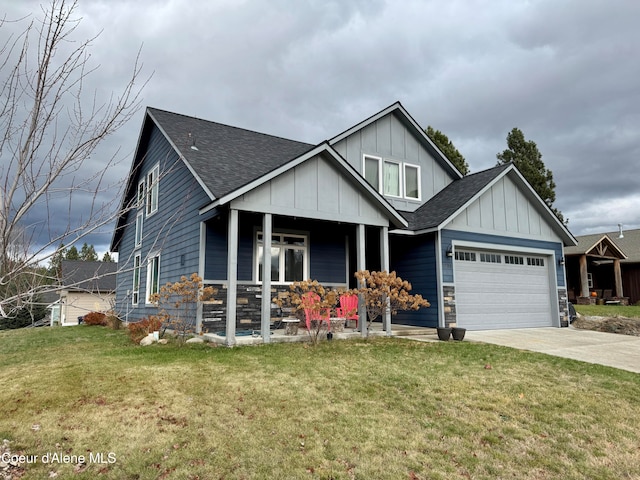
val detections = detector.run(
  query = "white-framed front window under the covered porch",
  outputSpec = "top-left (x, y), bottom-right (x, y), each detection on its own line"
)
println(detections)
top-left (256, 232), bottom-right (308, 283)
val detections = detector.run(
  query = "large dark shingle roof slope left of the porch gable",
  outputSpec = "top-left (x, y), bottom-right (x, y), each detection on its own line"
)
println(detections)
top-left (147, 108), bottom-right (314, 198)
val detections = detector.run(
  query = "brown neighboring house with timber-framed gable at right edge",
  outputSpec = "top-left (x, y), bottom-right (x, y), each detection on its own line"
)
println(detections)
top-left (565, 229), bottom-right (640, 305)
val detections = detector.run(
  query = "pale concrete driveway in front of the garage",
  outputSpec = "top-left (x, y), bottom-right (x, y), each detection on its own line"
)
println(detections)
top-left (465, 327), bottom-right (640, 373)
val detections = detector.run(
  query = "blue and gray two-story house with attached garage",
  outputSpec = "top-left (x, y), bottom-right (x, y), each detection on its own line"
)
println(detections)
top-left (111, 103), bottom-right (575, 344)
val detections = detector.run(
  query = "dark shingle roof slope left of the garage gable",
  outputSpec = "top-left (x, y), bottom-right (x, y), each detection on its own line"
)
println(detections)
top-left (401, 164), bottom-right (510, 230)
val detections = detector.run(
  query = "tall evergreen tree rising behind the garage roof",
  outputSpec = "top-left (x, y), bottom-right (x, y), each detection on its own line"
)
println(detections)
top-left (496, 128), bottom-right (568, 224)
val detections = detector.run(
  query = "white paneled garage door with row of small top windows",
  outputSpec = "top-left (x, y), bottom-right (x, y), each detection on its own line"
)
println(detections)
top-left (454, 250), bottom-right (553, 330)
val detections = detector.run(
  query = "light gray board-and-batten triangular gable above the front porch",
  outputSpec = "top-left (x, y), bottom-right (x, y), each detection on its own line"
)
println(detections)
top-left (231, 155), bottom-right (389, 226)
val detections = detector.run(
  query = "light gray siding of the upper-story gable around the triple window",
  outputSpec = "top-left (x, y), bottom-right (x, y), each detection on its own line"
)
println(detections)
top-left (333, 113), bottom-right (453, 211)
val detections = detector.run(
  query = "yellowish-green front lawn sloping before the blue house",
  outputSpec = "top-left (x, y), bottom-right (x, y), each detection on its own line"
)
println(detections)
top-left (0, 326), bottom-right (640, 479)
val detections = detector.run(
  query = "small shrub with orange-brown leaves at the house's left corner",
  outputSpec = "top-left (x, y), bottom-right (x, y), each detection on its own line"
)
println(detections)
top-left (151, 273), bottom-right (215, 343)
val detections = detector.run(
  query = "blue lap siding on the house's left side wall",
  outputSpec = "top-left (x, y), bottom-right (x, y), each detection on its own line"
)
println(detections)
top-left (116, 126), bottom-right (210, 321)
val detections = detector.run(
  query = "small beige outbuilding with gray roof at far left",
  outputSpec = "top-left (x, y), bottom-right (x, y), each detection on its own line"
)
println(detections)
top-left (59, 260), bottom-right (118, 325)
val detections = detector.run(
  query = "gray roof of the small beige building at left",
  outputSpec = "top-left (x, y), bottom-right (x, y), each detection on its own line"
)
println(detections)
top-left (62, 260), bottom-right (118, 292)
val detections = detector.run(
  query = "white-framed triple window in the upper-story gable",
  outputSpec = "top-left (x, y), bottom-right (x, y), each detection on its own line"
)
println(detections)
top-left (362, 155), bottom-right (421, 200)
